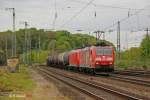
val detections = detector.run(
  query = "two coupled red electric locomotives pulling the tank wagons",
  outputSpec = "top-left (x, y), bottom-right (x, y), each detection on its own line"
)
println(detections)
top-left (69, 46), bottom-right (114, 73)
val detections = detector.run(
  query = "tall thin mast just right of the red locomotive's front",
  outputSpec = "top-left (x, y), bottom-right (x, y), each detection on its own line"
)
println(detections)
top-left (117, 21), bottom-right (120, 60)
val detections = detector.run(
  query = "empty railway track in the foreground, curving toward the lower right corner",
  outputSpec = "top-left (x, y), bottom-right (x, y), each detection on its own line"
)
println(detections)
top-left (34, 67), bottom-right (147, 100)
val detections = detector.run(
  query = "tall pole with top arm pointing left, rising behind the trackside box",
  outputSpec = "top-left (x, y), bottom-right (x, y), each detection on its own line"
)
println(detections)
top-left (6, 8), bottom-right (16, 57)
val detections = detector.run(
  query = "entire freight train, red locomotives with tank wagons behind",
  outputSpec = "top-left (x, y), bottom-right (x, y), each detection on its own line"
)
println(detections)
top-left (47, 46), bottom-right (115, 74)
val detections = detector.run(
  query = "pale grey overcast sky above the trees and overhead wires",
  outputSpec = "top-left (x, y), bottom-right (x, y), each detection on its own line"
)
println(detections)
top-left (0, 0), bottom-right (150, 49)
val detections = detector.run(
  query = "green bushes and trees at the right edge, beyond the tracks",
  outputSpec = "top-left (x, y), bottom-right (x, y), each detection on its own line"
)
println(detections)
top-left (116, 36), bottom-right (150, 69)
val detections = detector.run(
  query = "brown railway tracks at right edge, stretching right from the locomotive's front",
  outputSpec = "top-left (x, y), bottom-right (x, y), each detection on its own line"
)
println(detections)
top-left (110, 70), bottom-right (150, 86)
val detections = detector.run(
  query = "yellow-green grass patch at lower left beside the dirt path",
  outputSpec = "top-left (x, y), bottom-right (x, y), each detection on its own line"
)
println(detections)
top-left (0, 65), bottom-right (35, 100)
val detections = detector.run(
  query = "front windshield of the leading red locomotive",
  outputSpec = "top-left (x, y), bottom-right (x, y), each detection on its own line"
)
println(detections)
top-left (96, 48), bottom-right (112, 56)
